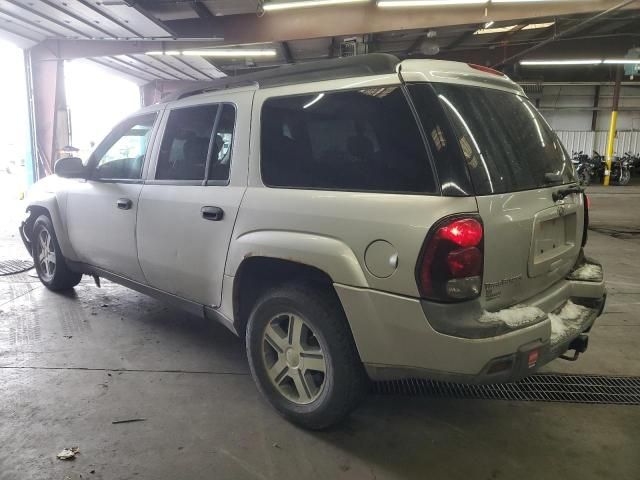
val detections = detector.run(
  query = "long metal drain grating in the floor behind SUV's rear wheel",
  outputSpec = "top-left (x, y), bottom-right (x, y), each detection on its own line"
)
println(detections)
top-left (373, 373), bottom-right (640, 405)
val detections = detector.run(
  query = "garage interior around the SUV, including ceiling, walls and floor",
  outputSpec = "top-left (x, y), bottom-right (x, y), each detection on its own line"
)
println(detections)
top-left (0, 0), bottom-right (640, 480)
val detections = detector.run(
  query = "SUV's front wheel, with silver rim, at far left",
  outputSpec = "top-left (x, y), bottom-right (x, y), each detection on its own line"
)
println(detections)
top-left (31, 215), bottom-right (82, 292)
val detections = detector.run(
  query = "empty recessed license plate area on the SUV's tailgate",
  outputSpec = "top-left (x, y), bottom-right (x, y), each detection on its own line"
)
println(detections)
top-left (529, 204), bottom-right (578, 277)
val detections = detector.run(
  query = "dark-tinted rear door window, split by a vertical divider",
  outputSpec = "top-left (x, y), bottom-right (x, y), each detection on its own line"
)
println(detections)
top-left (156, 105), bottom-right (235, 180)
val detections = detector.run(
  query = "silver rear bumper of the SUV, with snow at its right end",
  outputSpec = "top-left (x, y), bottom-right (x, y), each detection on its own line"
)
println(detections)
top-left (335, 260), bottom-right (606, 383)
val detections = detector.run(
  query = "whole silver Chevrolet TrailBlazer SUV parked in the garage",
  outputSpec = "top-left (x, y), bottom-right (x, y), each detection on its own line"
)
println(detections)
top-left (20, 54), bottom-right (605, 428)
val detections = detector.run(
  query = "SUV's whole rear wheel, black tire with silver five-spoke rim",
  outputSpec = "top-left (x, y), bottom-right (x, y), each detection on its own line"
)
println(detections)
top-left (246, 284), bottom-right (368, 430)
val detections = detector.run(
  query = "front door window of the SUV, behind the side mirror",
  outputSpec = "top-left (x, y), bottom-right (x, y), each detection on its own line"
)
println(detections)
top-left (93, 113), bottom-right (156, 180)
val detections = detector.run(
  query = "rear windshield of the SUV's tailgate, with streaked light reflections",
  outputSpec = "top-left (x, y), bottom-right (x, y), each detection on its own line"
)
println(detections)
top-left (420, 84), bottom-right (575, 195)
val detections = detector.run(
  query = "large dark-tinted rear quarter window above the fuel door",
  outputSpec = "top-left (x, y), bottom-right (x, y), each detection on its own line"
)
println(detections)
top-left (261, 87), bottom-right (435, 193)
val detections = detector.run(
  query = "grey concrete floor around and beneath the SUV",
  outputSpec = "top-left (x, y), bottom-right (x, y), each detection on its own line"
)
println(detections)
top-left (0, 173), bottom-right (640, 480)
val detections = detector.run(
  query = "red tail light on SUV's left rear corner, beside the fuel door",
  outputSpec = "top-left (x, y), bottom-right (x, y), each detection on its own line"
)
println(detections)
top-left (416, 216), bottom-right (484, 302)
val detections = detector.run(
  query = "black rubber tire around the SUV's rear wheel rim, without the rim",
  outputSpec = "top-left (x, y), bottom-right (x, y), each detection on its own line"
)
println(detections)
top-left (246, 284), bottom-right (368, 430)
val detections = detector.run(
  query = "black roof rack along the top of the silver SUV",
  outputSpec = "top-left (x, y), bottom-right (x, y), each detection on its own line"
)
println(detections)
top-left (162, 53), bottom-right (400, 102)
